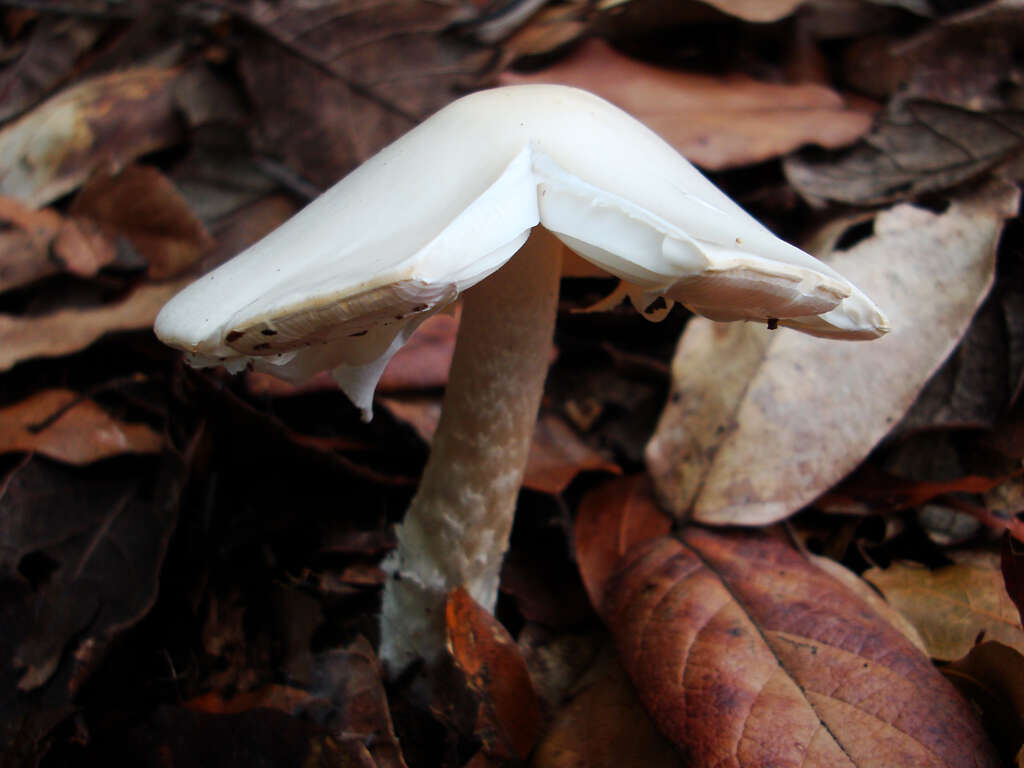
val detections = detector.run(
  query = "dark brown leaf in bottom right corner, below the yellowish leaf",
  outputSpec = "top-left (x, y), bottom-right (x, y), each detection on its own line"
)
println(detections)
top-left (942, 642), bottom-right (1024, 765)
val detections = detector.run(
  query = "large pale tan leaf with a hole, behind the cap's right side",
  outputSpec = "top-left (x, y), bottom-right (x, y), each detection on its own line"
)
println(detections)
top-left (647, 176), bottom-right (1018, 524)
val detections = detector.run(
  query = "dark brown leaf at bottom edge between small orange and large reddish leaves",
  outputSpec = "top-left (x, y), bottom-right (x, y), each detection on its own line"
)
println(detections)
top-left (531, 651), bottom-right (685, 768)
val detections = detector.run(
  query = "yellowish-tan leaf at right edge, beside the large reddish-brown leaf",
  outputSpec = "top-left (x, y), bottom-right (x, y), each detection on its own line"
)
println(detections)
top-left (864, 562), bottom-right (1024, 662)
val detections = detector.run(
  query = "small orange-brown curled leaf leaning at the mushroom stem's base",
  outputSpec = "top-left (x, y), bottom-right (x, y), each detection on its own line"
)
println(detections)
top-left (444, 587), bottom-right (541, 760)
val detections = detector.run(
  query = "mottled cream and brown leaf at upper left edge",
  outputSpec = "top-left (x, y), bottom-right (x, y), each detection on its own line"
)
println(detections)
top-left (0, 69), bottom-right (181, 207)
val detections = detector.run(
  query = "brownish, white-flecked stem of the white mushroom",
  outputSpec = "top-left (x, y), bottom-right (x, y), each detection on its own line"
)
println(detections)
top-left (380, 226), bottom-right (563, 674)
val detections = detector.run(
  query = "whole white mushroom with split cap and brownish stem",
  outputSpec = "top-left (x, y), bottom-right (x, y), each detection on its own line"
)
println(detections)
top-left (156, 85), bottom-right (887, 671)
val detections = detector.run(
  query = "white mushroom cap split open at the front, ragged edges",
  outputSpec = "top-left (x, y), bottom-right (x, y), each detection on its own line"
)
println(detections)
top-left (156, 85), bottom-right (887, 415)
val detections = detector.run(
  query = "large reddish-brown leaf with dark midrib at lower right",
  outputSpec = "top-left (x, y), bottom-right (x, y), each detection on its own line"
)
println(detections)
top-left (603, 528), bottom-right (997, 768)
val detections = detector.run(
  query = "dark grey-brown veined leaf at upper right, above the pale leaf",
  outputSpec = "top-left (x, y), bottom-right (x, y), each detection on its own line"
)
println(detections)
top-left (784, 99), bottom-right (1024, 205)
